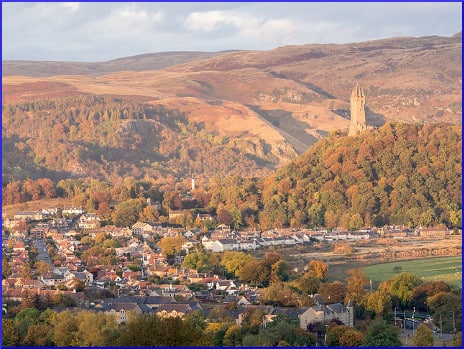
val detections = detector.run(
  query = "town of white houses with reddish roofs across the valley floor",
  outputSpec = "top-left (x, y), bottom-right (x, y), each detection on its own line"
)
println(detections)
top-left (2, 203), bottom-right (452, 327)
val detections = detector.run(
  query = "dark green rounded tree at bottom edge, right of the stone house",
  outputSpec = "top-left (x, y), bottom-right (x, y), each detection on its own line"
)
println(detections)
top-left (363, 318), bottom-right (402, 347)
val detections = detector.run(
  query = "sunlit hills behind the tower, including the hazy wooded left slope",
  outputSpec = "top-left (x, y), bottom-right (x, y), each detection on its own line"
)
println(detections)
top-left (2, 33), bottom-right (462, 182)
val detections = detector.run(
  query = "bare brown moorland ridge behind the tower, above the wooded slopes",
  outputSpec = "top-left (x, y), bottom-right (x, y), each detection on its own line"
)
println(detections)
top-left (2, 33), bottom-right (462, 182)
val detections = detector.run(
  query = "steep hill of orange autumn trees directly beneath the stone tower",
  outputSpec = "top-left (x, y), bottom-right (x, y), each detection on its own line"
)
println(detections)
top-left (260, 124), bottom-right (462, 228)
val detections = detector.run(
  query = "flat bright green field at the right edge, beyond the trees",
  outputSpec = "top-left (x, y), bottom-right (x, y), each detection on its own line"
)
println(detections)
top-left (364, 256), bottom-right (462, 288)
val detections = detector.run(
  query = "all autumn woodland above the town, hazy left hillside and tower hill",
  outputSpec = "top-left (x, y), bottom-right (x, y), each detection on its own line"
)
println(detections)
top-left (2, 95), bottom-right (462, 229)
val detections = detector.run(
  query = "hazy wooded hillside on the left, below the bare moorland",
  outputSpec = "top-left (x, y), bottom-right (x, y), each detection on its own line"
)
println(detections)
top-left (2, 95), bottom-right (276, 182)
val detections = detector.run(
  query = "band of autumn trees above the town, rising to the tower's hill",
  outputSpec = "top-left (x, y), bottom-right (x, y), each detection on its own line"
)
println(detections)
top-left (2, 124), bottom-right (462, 229)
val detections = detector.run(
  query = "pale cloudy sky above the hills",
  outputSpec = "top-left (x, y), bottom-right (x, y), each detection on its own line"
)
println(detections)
top-left (2, 2), bottom-right (462, 62)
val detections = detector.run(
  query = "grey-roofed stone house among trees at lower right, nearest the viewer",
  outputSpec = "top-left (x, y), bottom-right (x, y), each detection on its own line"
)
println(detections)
top-left (300, 303), bottom-right (354, 330)
